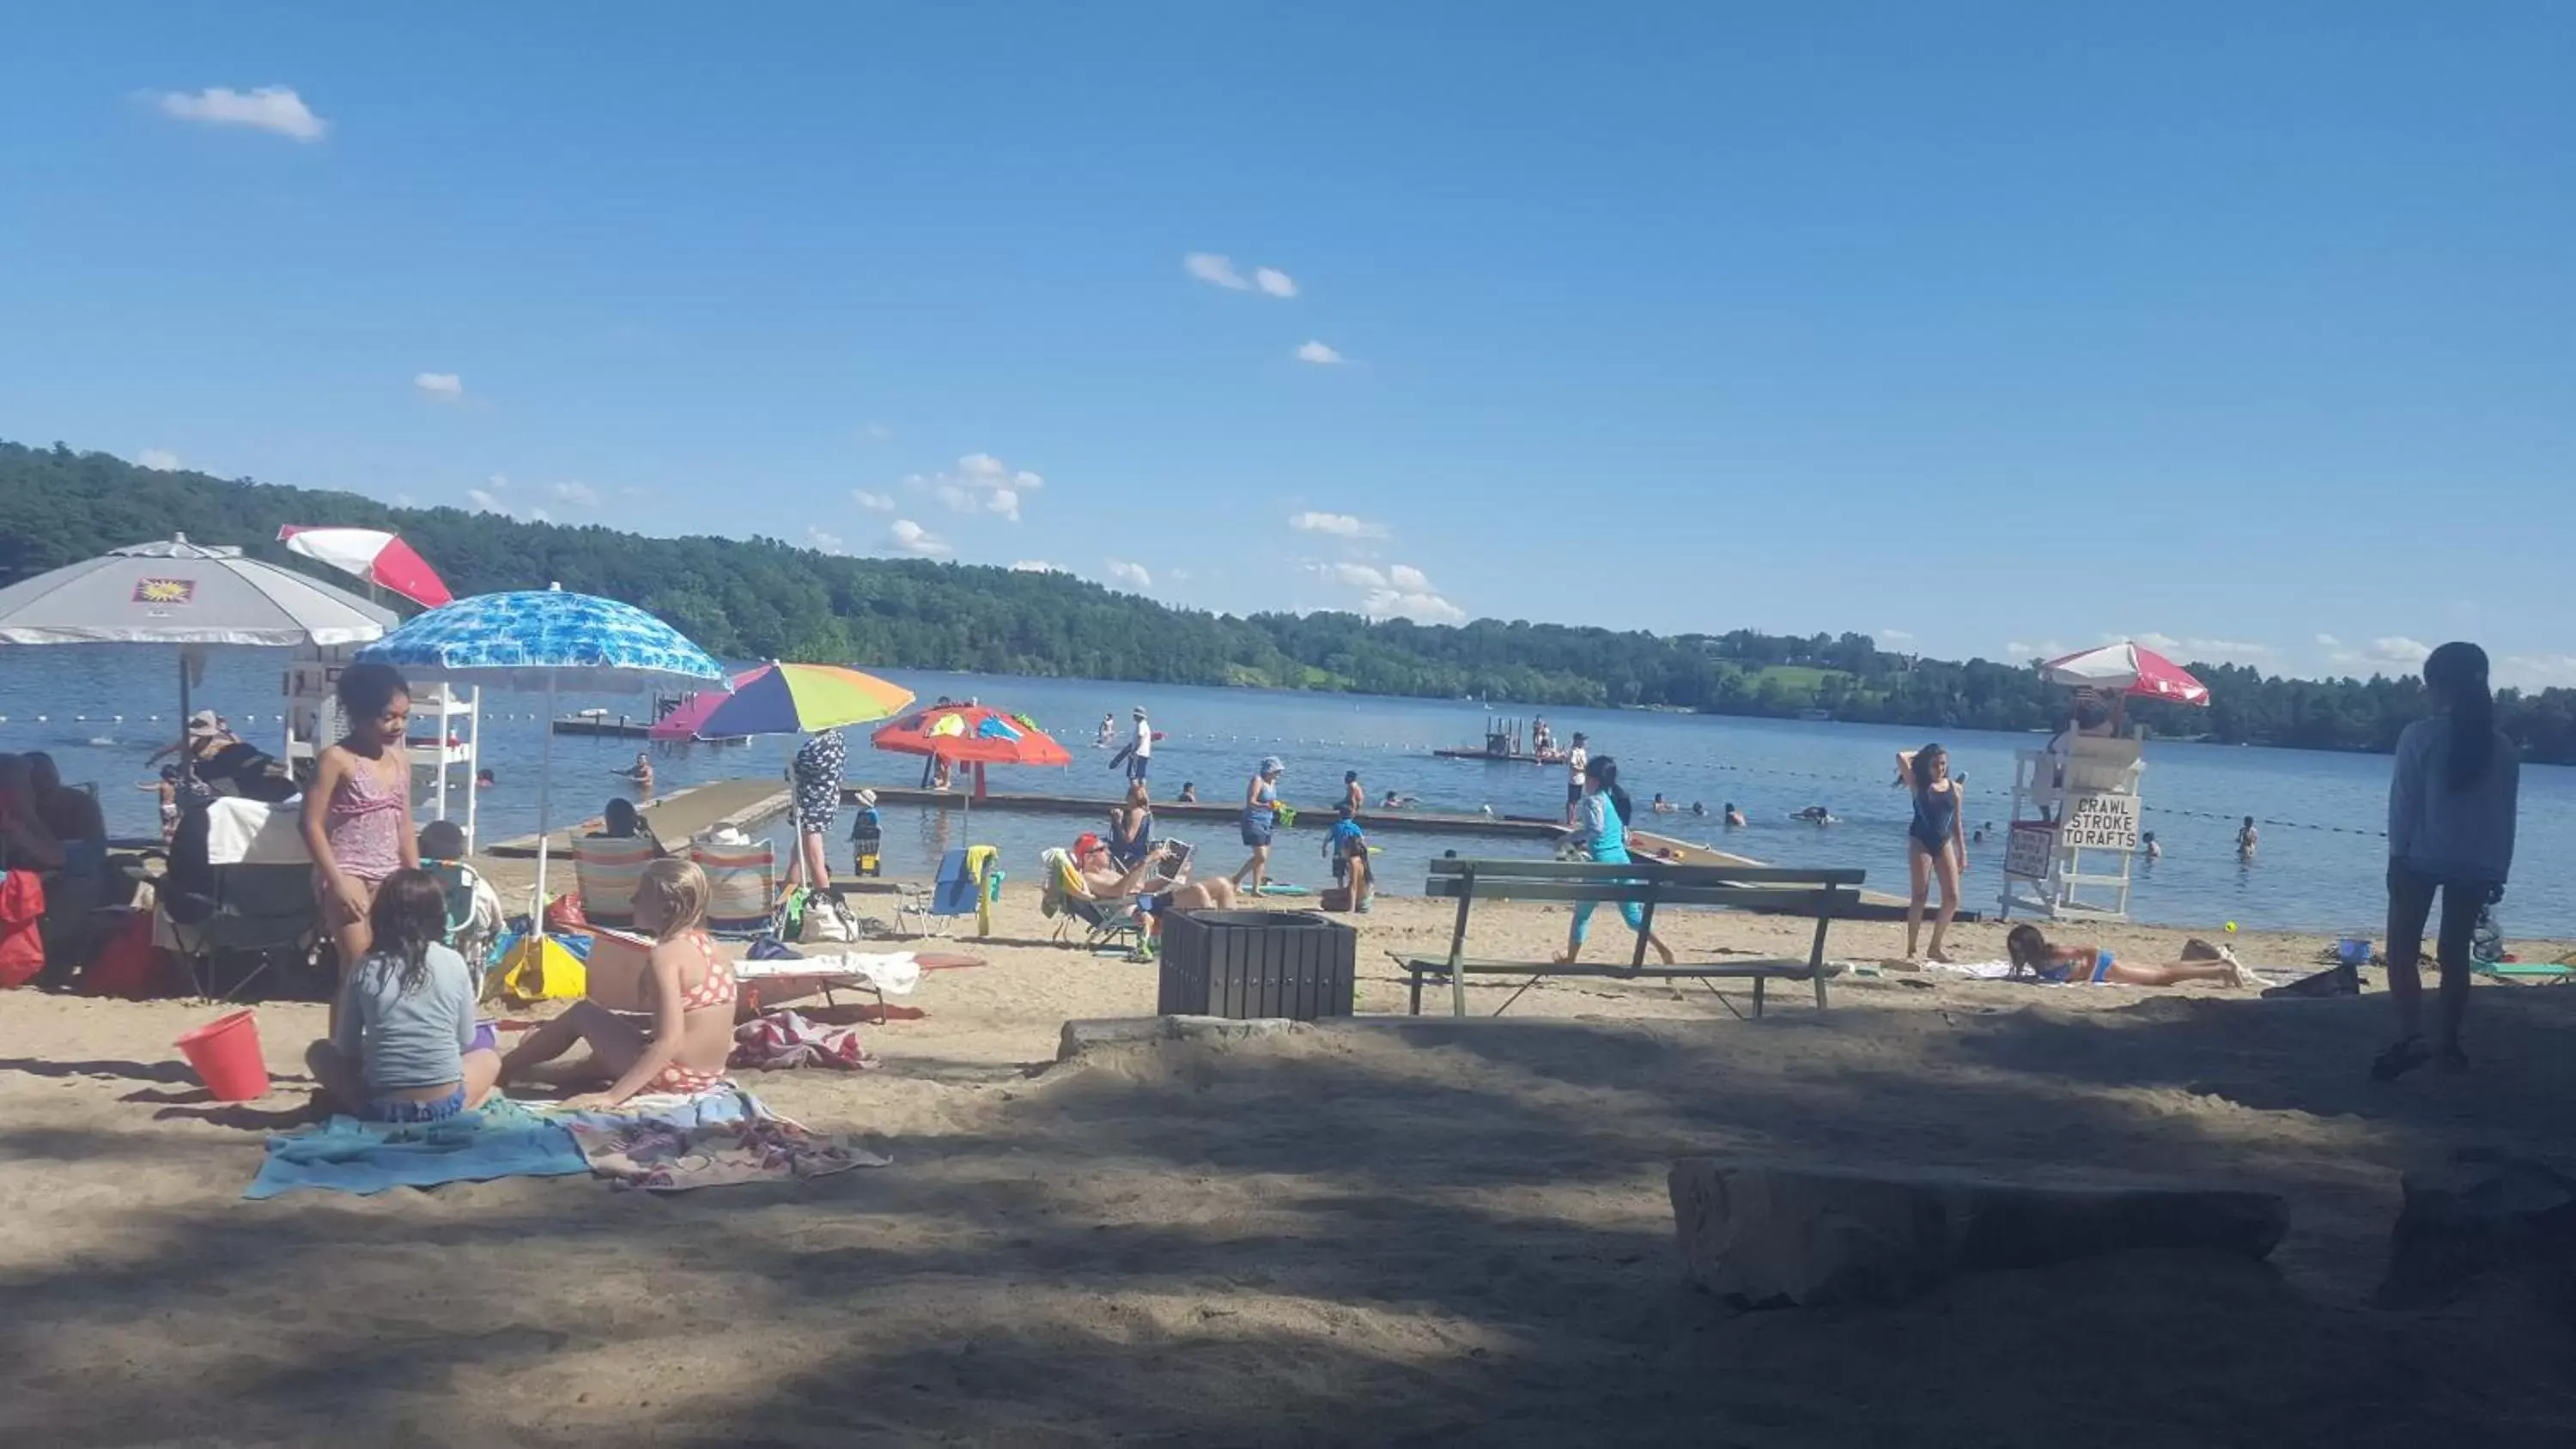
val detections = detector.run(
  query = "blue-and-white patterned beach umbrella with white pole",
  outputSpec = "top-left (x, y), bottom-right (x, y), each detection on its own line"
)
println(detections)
top-left (358, 587), bottom-right (729, 921)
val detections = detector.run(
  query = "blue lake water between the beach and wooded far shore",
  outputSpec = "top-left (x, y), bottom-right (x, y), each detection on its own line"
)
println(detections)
top-left (0, 646), bottom-right (2576, 937)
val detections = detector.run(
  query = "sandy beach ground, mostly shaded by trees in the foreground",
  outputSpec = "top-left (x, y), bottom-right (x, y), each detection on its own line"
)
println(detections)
top-left (0, 893), bottom-right (2576, 1446)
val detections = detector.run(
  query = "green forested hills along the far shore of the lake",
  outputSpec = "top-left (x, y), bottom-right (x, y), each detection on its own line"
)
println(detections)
top-left (0, 443), bottom-right (2576, 764)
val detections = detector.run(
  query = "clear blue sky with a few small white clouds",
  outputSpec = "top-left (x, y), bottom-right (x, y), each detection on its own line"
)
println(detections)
top-left (0, 3), bottom-right (2576, 685)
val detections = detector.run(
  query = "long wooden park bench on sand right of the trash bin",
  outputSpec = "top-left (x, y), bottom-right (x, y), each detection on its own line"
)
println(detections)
top-left (1396, 859), bottom-right (1865, 1016)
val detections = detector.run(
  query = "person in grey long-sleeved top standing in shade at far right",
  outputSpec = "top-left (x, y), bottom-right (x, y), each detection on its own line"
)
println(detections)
top-left (2370, 644), bottom-right (2522, 1081)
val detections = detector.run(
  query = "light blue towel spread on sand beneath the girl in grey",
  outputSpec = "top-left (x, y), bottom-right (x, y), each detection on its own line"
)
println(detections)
top-left (242, 1099), bottom-right (590, 1199)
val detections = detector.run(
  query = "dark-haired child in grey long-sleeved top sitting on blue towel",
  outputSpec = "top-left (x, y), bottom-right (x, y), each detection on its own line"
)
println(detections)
top-left (304, 867), bottom-right (500, 1122)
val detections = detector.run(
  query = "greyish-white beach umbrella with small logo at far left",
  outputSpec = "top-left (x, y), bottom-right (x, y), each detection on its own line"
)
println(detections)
top-left (0, 533), bottom-right (402, 767)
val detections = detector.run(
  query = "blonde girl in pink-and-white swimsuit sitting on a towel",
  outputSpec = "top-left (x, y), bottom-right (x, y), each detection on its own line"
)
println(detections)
top-left (500, 859), bottom-right (739, 1106)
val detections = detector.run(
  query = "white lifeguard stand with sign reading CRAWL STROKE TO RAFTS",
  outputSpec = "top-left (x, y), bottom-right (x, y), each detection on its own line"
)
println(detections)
top-left (2002, 733), bottom-right (2146, 921)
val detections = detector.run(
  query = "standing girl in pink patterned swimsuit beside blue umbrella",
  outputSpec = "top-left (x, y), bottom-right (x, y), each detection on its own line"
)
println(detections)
top-left (304, 664), bottom-right (420, 988)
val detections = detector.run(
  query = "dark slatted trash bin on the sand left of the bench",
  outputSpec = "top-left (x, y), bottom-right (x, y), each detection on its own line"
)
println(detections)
top-left (1154, 911), bottom-right (1360, 1022)
